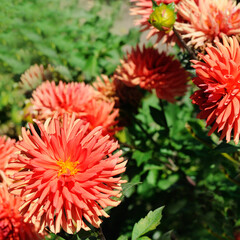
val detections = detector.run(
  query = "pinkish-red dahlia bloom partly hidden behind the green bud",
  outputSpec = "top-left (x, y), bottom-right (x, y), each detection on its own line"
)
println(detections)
top-left (130, 0), bottom-right (181, 44)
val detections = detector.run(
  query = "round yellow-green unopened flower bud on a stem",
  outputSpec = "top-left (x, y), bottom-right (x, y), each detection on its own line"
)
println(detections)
top-left (148, 3), bottom-right (177, 33)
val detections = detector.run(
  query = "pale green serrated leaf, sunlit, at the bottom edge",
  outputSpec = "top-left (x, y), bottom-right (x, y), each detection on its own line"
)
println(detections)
top-left (132, 207), bottom-right (164, 240)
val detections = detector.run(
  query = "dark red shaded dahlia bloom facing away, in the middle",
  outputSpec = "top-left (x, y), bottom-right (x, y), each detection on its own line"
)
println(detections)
top-left (114, 46), bottom-right (189, 102)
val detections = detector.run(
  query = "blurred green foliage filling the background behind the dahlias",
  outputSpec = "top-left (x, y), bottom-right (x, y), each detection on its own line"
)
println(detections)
top-left (0, 0), bottom-right (240, 240)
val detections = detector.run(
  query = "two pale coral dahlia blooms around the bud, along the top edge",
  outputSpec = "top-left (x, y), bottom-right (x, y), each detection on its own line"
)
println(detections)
top-left (130, 0), bottom-right (240, 49)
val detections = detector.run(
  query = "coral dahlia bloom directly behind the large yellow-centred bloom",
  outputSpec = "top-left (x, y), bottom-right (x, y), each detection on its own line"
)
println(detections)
top-left (32, 81), bottom-right (119, 136)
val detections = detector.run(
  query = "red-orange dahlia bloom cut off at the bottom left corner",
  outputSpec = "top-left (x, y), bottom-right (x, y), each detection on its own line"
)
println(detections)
top-left (0, 183), bottom-right (44, 240)
